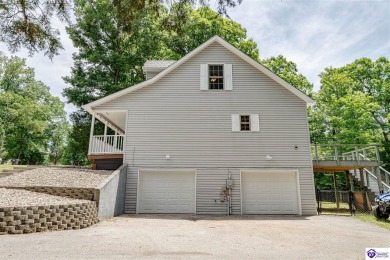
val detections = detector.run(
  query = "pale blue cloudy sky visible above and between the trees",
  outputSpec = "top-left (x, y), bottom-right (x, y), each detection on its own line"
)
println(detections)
top-left (0, 0), bottom-right (390, 115)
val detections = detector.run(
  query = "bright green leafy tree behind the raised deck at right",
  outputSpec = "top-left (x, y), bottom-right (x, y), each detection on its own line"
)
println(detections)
top-left (311, 57), bottom-right (390, 168)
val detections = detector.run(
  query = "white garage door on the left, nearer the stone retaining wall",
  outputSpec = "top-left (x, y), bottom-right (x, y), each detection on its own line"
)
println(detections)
top-left (137, 170), bottom-right (195, 213)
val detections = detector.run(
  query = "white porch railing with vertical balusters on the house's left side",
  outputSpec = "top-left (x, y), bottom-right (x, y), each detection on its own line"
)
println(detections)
top-left (88, 135), bottom-right (125, 154)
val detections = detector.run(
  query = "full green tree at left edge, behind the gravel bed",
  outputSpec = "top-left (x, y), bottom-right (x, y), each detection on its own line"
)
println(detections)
top-left (0, 55), bottom-right (65, 164)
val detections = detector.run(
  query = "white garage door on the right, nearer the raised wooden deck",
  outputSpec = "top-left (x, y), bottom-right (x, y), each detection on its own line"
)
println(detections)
top-left (241, 171), bottom-right (299, 214)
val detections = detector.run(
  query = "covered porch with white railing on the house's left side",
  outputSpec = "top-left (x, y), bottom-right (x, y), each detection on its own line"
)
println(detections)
top-left (88, 110), bottom-right (127, 170)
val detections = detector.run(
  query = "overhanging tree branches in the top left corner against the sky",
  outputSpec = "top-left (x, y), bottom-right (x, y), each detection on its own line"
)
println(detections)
top-left (0, 0), bottom-right (71, 58)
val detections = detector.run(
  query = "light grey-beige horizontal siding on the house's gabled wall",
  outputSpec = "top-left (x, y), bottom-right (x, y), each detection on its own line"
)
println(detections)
top-left (94, 43), bottom-right (315, 214)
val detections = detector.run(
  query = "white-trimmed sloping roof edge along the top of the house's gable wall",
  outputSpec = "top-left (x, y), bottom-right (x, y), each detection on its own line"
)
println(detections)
top-left (82, 36), bottom-right (314, 113)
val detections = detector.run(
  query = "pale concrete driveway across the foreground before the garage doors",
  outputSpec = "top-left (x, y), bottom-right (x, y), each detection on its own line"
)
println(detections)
top-left (0, 215), bottom-right (390, 259)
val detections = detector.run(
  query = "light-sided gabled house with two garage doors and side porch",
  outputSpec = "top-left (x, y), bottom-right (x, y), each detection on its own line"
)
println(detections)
top-left (84, 36), bottom-right (316, 215)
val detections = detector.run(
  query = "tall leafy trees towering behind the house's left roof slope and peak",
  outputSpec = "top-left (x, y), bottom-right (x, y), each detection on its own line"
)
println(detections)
top-left (64, 0), bottom-right (258, 162)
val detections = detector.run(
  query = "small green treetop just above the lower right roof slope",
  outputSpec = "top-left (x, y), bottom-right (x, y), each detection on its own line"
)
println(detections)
top-left (260, 55), bottom-right (314, 97)
